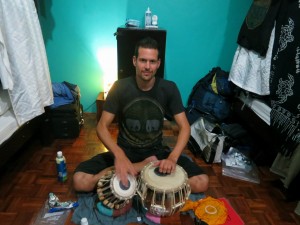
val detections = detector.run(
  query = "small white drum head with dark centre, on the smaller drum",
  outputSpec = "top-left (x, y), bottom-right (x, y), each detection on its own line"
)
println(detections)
top-left (110, 174), bottom-right (137, 199)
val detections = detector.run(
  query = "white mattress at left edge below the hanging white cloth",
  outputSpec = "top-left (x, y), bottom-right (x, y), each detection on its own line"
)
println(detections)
top-left (0, 108), bottom-right (19, 145)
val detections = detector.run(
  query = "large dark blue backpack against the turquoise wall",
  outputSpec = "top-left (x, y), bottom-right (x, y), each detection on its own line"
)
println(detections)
top-left (185, 67), bottom-right (234, 125)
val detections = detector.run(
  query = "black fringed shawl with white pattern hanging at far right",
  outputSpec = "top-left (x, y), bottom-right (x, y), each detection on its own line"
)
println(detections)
top-left (270, 0), bottom-right (300, 156)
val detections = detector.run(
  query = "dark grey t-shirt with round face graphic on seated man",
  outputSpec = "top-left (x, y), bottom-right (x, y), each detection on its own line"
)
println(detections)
top-left (104, 77), bottom-right (184, 149)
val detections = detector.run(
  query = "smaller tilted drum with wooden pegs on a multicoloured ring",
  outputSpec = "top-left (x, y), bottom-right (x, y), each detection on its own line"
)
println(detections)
top-left (96, 169), bottom-right (137, 217)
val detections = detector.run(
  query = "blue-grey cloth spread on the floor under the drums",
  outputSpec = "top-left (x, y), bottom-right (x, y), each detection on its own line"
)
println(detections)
top-left (72, 192), bottom-right (205, 225)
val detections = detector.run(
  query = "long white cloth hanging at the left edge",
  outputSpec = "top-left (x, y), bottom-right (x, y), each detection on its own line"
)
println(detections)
top-left (0, 0), bottom-right (53, 125)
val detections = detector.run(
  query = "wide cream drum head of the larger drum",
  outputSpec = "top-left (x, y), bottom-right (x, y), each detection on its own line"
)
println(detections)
top-left (141, 163), bottom-right (187, 191)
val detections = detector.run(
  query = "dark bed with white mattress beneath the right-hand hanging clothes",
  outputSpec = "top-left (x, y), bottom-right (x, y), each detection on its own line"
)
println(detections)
top-left (233, 91), bottom-right (300, 201)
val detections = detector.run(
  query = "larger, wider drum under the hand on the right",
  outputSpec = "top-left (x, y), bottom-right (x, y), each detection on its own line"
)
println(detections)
top-left (137, 163), bottom-right (191, 216)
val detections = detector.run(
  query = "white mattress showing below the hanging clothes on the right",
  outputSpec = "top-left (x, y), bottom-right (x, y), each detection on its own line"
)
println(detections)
top-left (239, 92), bottom-right (271, 125)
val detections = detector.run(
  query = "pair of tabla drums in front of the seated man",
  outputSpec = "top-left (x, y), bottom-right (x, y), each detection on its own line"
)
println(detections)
top-left (97, 163), bottom-right (191, 217)
